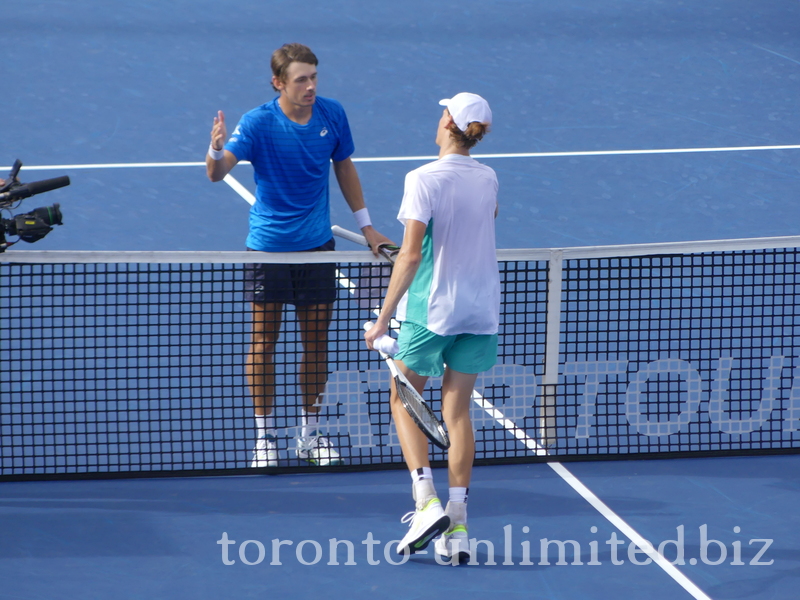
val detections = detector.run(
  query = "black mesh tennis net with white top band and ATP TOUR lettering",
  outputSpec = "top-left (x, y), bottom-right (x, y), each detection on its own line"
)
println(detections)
top-left (0, 238), bottom-right (800, 479)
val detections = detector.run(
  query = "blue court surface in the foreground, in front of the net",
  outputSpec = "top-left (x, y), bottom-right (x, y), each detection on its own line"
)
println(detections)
top-left (0, 456), bottom-right (800, 599)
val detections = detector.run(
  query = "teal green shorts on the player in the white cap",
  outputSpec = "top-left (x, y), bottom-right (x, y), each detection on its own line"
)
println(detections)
top-left (395, 321), bottom-right (497, 377)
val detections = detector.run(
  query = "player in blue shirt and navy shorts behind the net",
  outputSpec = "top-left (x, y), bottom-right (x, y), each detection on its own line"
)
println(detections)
top-left (206, 44), bottom-right (391, 467)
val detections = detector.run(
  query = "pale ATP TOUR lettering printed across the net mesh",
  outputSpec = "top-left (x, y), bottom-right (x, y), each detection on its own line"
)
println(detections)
top-left (322, 355), bottom-right (800, 447)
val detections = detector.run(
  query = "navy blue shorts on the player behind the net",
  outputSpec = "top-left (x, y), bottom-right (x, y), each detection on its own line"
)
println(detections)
top-left (244, 238), bottom-right (337, 306)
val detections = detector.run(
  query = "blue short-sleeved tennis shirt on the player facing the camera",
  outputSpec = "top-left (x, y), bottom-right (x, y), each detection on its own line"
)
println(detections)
top-left (225, 96), bottom-right (355, 252)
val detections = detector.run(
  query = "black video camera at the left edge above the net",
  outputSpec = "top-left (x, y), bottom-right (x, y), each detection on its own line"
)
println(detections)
top-left (0, 159), bottom-right (69, 252)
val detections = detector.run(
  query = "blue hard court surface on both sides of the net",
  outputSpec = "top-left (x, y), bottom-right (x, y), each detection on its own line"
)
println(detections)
top-left (0, 0), bottom-right (800, 599)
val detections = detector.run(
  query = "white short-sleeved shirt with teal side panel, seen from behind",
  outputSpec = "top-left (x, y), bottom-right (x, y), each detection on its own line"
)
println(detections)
top-left (397, 154), bottom-right (500, 335)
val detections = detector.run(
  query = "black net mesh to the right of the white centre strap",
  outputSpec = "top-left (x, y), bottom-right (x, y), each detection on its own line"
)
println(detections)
top-left (551, 249), bottom-right (800, 455)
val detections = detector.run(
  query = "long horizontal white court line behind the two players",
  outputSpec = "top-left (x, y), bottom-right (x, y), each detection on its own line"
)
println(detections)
top-left (0, 145), bottom-right (800, 171)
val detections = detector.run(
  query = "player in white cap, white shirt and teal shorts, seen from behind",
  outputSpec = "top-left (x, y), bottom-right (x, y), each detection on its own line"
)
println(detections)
top-left (364, 93), bottom-right (500, 563)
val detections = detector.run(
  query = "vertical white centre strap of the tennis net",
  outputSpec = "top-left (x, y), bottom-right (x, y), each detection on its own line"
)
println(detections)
top-left (537, 248), bottom-right (564, 447)
